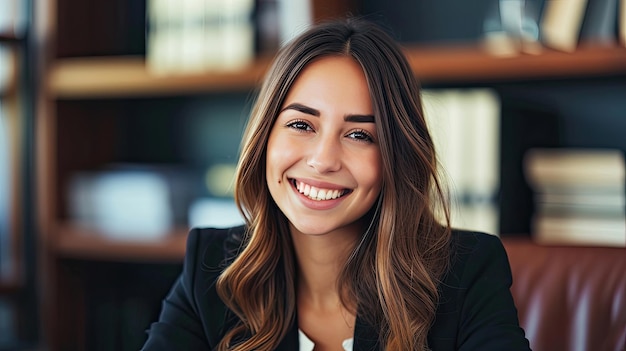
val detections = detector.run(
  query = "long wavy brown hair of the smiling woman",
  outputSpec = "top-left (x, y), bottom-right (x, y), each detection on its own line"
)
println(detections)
top-left (217, 19), bottom-right (450, 350)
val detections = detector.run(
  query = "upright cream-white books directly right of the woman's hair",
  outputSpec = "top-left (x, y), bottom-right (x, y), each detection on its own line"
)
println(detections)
top-left (422, 88), bottom-right (500, 234)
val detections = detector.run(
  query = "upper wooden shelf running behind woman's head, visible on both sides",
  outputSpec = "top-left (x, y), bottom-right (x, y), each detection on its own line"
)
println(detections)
top-left (49, 47), bottom-right (626, 99)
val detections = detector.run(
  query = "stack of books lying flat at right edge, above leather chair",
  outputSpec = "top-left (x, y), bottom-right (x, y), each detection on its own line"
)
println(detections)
top-left (524, 148), bottom-right (626, 247)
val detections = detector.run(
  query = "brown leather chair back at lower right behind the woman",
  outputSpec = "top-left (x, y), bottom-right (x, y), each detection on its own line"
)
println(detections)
top-left (502, 237), bottom-right (626, 351)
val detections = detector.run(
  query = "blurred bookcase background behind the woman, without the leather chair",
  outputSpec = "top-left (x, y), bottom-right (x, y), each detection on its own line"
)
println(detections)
top-left (0, 0), bottom-right (626, 350)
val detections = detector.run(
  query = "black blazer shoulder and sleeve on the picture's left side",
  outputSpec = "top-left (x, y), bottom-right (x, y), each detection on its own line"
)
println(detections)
top-left (144, 227), bottom-right (245, 350)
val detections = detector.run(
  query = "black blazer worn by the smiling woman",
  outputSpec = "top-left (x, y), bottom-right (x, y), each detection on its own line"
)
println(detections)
top-left (143, 227), bottom-right (529, 351)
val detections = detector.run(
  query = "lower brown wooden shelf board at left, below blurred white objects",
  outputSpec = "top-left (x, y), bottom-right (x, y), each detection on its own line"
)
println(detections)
top-left (53, 223), bottom-right (188, 262)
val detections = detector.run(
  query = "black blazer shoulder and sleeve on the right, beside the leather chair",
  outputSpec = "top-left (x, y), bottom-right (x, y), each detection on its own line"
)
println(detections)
top-left (430, 230), bottom-right (529, 350)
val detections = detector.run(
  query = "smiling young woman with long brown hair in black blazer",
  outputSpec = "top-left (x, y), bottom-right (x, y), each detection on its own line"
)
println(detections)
top-left (144, 19), bottom-right (529, 351)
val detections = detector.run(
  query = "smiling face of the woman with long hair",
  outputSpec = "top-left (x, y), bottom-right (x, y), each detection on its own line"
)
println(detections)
top-left (266, 56), bottom-right (382, 235)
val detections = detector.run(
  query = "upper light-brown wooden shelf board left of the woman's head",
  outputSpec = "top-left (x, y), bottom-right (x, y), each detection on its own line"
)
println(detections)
top-left (49, 57), bottom-right (270, 99)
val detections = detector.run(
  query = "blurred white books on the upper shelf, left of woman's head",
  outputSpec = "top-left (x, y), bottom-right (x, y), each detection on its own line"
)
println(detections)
top-left (144, 0), bottom-right (313, 75)
